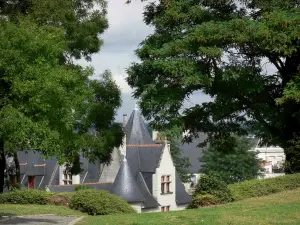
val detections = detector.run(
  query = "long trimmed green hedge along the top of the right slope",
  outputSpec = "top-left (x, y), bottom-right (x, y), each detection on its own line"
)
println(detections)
top-left (229, 174), bottom-right (300, 201)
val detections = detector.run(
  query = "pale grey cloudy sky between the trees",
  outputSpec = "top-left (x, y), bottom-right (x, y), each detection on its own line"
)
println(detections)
top-left (80, 0), bottom-right (210, 121)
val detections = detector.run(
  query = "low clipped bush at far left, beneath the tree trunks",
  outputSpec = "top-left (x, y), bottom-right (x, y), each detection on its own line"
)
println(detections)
top-left (0, 189), bottom-right (51, 205)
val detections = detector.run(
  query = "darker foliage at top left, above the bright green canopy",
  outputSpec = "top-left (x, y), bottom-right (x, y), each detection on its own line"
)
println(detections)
top-left (0, 0), bottom-right (108, 59)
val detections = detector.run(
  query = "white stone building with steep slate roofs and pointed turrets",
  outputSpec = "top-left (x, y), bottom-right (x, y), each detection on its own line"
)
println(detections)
top-left (7, 108), bottom-right (191, 212)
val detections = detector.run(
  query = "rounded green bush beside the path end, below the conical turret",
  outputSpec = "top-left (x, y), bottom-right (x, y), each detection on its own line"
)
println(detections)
top-left (70, 190), bottom-right (135, 215)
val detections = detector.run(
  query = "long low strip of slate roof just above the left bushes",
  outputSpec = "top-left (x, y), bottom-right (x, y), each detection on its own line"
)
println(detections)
top-left (48, 183), bottom-right (112, 192)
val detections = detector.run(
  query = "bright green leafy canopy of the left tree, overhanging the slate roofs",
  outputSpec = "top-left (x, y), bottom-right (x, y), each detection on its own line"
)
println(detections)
top-left (0, 18), bottom-right (122, 166)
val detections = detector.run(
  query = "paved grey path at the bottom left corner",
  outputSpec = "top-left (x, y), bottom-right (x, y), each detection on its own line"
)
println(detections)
top-left (0, 215), bottom-right (82, 225)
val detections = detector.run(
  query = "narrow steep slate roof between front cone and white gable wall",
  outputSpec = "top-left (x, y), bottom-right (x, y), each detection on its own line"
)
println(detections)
top-left (137, 173), bottom-right (160, 208)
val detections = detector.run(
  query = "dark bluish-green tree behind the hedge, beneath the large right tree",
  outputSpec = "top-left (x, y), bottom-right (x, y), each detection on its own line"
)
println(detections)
top-left (200, 137), bottom-right (262, 184)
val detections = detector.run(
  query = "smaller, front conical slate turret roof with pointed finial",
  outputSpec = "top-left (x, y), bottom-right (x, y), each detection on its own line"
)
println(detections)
top-left (111, 157), bottom-right (144, 202)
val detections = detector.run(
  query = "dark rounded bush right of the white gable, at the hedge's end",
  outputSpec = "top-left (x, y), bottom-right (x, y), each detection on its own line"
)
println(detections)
top-left (194, 174), bottom-right (232, 203)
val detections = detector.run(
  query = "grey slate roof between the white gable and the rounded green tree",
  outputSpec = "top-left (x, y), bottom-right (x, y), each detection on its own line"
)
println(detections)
top-left (178, 133), bottom-right (207, 173)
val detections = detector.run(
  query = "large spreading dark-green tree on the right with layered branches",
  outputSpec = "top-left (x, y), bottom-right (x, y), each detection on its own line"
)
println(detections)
top-left (128, 0), bottom-right (300, 173)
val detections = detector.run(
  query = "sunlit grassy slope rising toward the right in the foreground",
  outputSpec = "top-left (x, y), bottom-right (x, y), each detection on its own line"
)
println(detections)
top-left (82, 189), bottom-right (300, 225)
